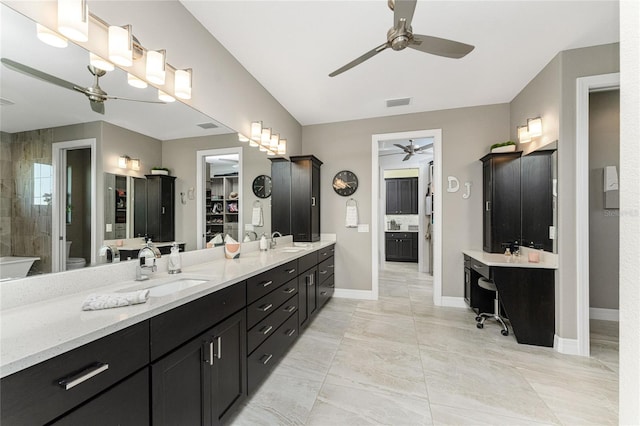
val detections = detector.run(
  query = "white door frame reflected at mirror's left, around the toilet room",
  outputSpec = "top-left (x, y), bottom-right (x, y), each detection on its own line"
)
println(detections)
top-left (51, 138), bottom-right (99, 272)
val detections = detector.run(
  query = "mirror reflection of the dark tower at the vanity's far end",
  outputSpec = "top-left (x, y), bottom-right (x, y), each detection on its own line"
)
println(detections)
top-left (270, 158), bottom-right (291, 235)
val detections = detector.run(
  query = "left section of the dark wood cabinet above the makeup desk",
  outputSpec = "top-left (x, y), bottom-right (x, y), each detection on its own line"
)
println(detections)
top-left (480, 152), bottom-right (522, 253)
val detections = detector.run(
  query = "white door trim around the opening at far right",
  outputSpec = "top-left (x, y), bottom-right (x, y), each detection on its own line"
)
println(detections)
top-left (576, 73), bottom-right (620, 356)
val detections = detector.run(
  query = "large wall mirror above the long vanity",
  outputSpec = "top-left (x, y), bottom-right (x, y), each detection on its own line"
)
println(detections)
top-left (0, 4), bottom-right (270, 274)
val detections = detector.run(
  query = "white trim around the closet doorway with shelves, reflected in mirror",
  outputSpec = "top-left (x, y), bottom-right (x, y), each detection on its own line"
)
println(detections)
top-left (196, 147), bottom-right (242, 249)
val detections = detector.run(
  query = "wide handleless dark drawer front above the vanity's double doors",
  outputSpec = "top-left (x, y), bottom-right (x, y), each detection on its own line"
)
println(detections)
top-left (150, 281), bottom-right (246, 360)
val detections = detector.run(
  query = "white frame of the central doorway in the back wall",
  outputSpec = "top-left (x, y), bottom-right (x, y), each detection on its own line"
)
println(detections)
top-left (371, 129), bottom-right (442, 305)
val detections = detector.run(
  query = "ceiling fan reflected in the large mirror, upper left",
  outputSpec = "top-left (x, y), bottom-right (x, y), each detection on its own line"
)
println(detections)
top-left (0, 58), bottom-right (164, 114)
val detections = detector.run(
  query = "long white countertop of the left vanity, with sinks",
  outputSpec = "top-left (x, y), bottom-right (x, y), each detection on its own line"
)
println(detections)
top-left (0, 241), bottom-right (335, 377)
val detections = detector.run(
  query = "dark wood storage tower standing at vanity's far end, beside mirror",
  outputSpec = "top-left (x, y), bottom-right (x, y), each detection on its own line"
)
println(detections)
top-left (290, 155), bottom-right (322, 241)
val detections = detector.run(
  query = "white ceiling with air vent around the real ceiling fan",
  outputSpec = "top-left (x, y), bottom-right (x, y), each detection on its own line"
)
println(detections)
top-left (181, 0), bottom-right (619, 125)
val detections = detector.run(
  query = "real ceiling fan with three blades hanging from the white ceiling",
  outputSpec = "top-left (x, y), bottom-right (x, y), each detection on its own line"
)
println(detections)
top-left (329, 0), bottom-right (474, 77)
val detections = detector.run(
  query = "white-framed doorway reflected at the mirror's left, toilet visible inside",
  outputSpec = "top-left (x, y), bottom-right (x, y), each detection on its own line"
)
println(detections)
top-left (52, 139), bottom-right (98, 272)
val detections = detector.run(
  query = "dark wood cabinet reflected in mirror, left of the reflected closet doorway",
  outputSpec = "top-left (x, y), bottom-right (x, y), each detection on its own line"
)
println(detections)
top-left (146, 175), bottom-right (176, 242)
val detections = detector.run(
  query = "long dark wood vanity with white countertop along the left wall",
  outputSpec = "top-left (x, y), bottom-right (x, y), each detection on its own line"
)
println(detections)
top-left (0, 239), bottom-right (335, 425)
